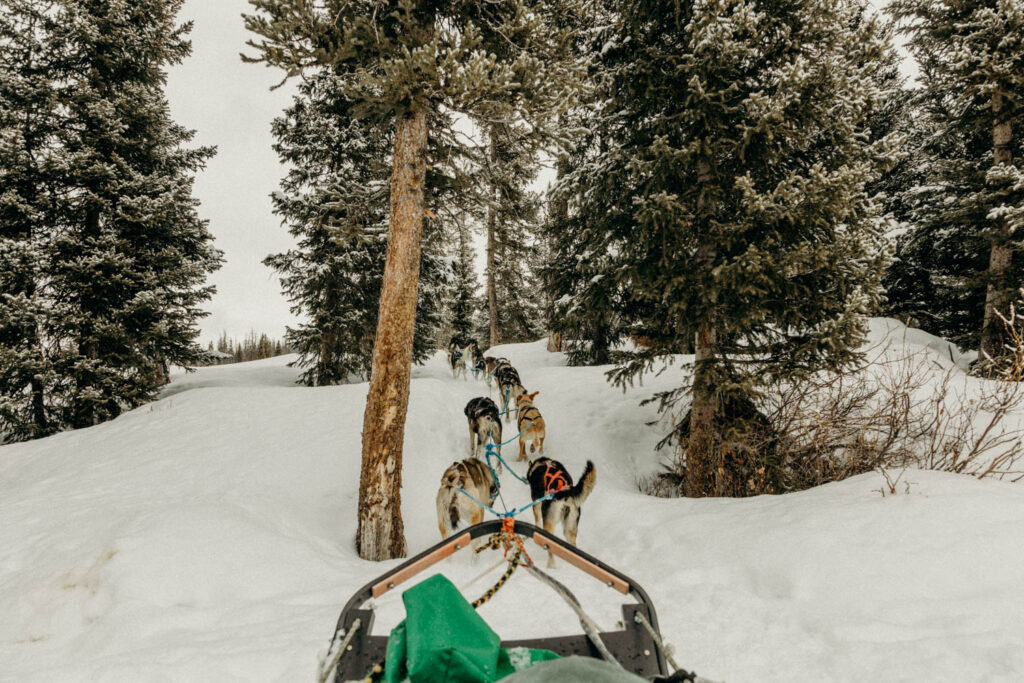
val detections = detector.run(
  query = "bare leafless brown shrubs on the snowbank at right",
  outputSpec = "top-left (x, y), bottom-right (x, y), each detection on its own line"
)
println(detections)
top-left (638, 309), bottom-right (1024, 497)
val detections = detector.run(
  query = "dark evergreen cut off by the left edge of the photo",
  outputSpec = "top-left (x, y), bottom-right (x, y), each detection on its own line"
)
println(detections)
top-left (0, 0), bottom-right (63, 441)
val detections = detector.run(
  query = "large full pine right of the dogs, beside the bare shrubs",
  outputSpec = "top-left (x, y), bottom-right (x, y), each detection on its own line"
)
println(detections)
top-left (564, 0), bottom-right (893, 496)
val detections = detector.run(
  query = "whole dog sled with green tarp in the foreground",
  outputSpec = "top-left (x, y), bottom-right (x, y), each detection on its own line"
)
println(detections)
top-left (321, 517), bottom-right (703, 683)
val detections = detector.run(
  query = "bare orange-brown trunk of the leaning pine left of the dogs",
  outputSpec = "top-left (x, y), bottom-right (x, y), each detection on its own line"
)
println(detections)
top-left (356, 110), bottom-right (428, 560)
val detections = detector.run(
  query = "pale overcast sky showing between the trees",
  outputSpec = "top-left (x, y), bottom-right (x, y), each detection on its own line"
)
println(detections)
top-left (167, 0), bottom-right (913, 344)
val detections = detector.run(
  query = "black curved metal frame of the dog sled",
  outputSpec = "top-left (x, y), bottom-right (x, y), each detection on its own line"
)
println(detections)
top-left (332, 519), bottom-right (670, 683)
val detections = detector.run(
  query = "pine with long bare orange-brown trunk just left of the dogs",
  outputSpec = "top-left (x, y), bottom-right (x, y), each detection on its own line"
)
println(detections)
top-left (246, 0), bottom-right (562, 559)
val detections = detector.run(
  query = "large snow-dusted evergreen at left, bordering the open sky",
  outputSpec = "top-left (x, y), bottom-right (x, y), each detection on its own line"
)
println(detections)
top-left (0, 0), bottom-right (219, 438)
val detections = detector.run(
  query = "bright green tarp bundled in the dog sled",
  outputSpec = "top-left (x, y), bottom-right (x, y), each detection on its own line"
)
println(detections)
top-left (384, 574), bottom-right (558, 683)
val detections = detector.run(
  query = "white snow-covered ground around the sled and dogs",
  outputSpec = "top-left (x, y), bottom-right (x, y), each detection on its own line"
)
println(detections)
top-left (0, 321), bottom-right (1024, 683)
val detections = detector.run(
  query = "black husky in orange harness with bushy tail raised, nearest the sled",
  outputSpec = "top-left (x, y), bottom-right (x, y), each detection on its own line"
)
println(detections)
top-left (526, 458), bottom-right (597, 567)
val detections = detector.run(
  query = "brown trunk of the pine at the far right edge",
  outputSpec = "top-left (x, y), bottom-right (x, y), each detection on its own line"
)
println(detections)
top-left (980, 93), bottom-right (1015, 358)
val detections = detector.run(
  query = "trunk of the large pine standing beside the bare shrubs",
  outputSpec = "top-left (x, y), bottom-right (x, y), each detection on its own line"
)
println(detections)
top-left (683, 162), bottom-right (720, 498)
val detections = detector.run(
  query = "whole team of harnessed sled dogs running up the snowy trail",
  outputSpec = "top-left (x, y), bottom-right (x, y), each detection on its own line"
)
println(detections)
top-left (437, 337), bottom-right (597, 566)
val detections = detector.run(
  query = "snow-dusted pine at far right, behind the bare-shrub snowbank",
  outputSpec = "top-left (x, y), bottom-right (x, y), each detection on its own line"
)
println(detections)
top-left (890, 0), bottom-right (1024, 357)
